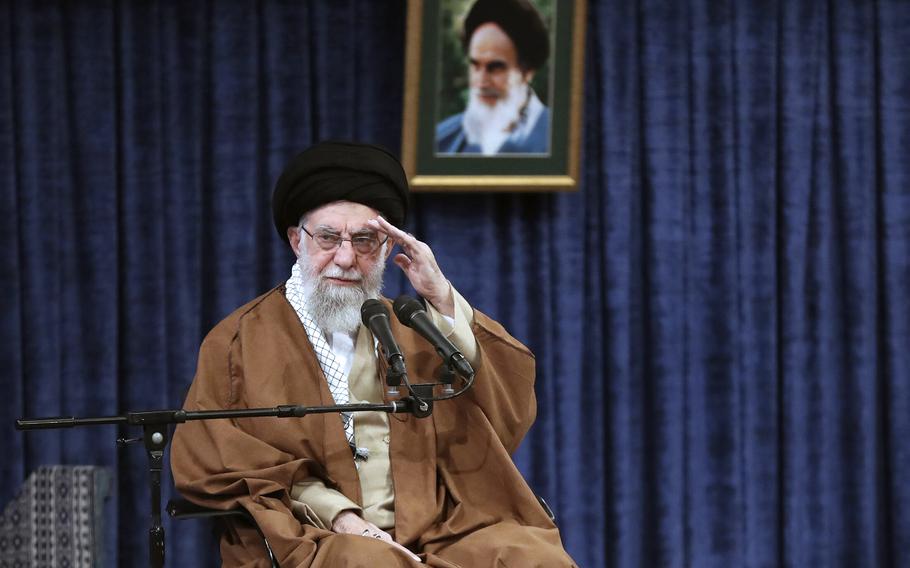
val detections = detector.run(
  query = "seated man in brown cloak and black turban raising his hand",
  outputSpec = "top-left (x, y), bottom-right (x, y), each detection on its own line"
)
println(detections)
top-left (171, 142), bottom-right (574, 568)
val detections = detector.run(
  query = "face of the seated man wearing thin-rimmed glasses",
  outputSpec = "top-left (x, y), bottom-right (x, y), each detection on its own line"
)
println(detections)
top-left (288, 201), bottom-right (391, 288)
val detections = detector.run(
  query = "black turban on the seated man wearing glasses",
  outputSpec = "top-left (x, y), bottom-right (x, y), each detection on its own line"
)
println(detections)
top-left (272, 142), bottom-right (409, 241)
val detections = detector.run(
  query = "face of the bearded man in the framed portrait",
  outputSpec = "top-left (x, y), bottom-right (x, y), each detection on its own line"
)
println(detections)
top-left (468, 22), bottom-right (530, 107)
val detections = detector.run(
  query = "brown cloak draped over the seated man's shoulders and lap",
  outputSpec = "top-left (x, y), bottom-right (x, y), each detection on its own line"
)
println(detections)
top-left (171, 286), bottom-right (575, 568)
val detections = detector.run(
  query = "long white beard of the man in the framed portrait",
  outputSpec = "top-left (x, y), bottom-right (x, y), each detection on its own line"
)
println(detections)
top-left (461, 69), bottom-right (528, 156)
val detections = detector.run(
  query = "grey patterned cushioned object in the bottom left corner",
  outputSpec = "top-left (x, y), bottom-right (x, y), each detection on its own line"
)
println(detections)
top-left (0, 465), bottom-right (110, 568)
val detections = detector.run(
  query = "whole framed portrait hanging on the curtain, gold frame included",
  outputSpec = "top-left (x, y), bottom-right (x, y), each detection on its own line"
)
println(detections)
top-left (402, 0), bottom-right (585, 191)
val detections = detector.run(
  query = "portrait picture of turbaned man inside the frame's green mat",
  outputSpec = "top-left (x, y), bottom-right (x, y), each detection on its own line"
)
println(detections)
top-left (435, 0), bottom-right (552, 156)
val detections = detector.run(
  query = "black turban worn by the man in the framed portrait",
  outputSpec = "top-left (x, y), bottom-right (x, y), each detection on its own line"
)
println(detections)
top-left (461, 0), bottom-right (550, 71)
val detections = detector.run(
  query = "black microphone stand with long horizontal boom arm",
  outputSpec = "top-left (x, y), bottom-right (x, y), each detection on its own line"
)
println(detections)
top-left (16, 383), bottom-right (436, 568)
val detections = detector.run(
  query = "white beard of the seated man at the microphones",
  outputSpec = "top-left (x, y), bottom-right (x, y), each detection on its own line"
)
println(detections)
top-left (297, 243), bottom-right (388, 337)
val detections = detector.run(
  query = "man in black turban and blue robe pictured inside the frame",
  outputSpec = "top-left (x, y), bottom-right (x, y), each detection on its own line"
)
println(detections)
top-left (436, 0), bottom-right (550, 155)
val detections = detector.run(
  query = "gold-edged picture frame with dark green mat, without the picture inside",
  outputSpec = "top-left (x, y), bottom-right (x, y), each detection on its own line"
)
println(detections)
top-left (402, 0), bottom-right (586, 192)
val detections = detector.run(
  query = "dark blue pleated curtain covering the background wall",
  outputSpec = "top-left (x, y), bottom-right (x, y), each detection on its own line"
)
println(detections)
top-left (0, 0), bottom-right (910, 567)
